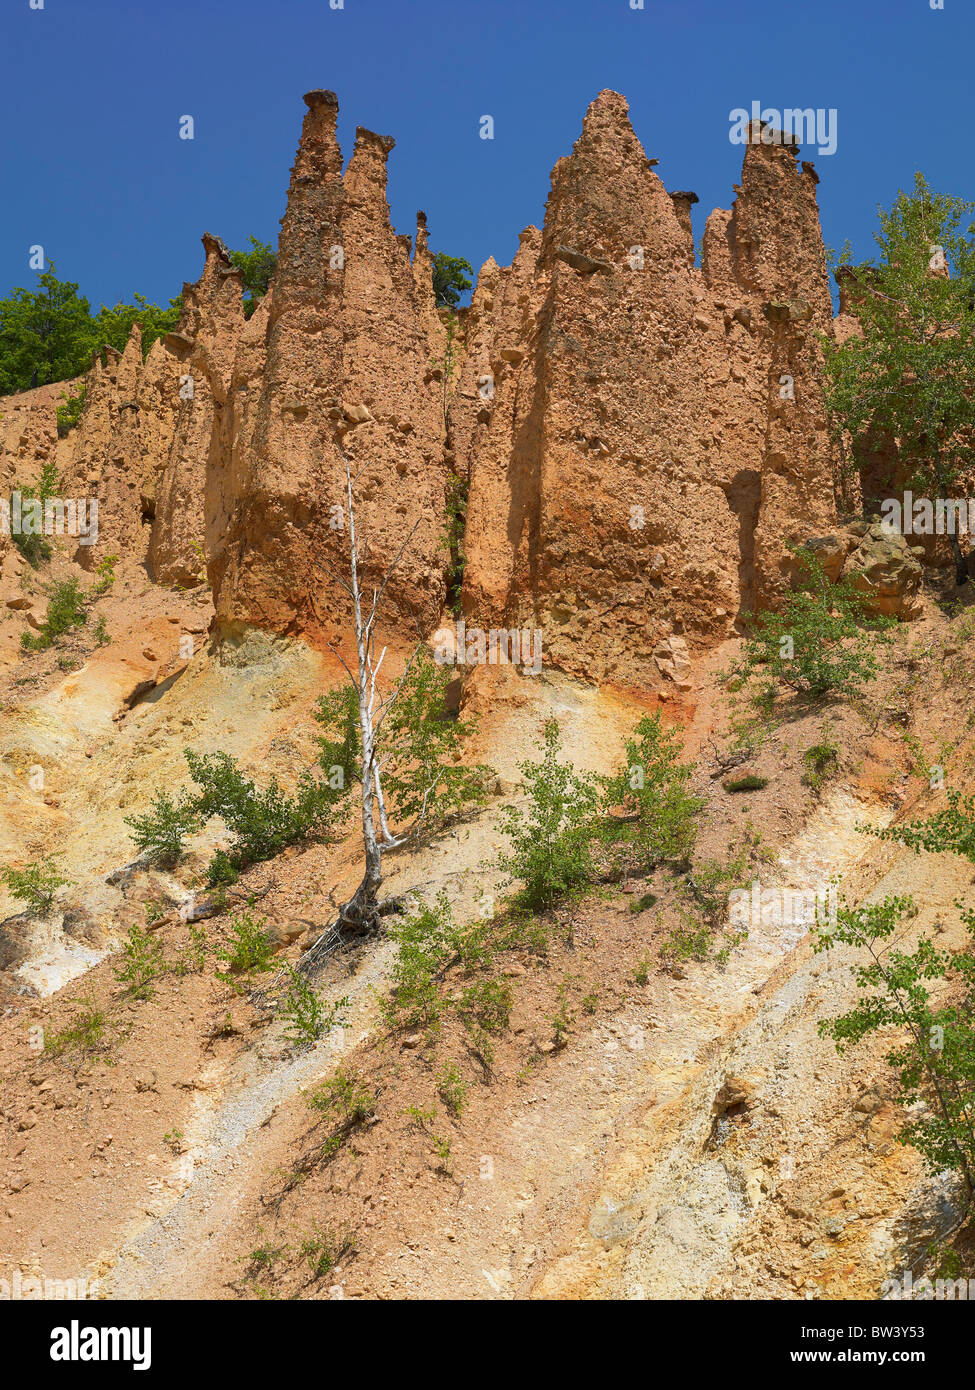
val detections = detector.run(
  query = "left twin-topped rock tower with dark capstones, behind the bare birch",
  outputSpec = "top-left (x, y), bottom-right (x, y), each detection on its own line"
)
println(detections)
top-left (207, 92), bottom-right (446, 635)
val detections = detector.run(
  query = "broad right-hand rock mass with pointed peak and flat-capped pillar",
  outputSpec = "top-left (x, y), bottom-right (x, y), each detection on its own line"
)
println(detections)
top-left (455, 92), bottom-right (833, 685)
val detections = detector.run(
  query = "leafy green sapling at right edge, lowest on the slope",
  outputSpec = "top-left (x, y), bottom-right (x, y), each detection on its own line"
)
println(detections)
top-left (814, 897), bottom-right (975, 1201)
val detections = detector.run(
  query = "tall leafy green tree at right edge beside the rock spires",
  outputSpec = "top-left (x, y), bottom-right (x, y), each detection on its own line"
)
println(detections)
top-left (823, 174), bottom-right (975, 584)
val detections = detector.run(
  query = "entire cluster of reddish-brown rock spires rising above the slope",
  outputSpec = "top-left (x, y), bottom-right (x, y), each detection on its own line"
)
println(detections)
top-left (1, 92), bottom-right (906, 688)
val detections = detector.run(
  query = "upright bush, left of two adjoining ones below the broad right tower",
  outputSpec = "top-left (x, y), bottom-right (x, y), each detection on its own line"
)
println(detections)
top-left (498, 719), bottom-right (599, 909)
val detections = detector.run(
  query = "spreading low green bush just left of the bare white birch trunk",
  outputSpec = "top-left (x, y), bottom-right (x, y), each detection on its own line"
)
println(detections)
top-left (185, 748), bottom-right (337, 883)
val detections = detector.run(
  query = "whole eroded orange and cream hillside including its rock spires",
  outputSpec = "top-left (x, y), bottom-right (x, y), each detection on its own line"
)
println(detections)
top-left (0, 90), bottom-right (972, 1298)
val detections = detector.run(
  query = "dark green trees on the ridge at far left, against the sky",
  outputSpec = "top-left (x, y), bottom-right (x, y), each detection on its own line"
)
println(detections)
top-left (0, 264), bottom-right (181, 394)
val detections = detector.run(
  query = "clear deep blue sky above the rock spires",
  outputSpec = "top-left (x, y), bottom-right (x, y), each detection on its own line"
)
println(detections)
top-left (0, 0), bottom-right (975, 307)
